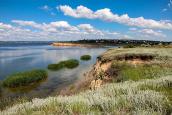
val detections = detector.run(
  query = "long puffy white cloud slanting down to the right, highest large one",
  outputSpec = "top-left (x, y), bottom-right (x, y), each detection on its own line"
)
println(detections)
top-left (57, 5), bottom-right (172, 30)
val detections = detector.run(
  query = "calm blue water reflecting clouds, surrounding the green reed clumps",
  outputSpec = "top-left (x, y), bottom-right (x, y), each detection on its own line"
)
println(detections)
top-left (0, 44), bottom-right (107, 98)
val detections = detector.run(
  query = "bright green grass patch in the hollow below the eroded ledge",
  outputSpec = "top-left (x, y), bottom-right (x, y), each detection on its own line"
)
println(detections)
top-left (112, 61), bottom-right (172, 81)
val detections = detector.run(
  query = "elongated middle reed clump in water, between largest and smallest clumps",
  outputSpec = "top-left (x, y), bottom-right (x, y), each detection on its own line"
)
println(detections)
top-left (47, 59), bottom-right (79, 71)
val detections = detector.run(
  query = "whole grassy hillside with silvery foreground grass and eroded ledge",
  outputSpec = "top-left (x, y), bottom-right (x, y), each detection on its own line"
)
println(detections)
top-left (0, 48), bottom-right (172, 115)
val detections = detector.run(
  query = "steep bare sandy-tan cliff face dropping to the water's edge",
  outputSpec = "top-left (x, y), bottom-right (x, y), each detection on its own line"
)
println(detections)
top-left (60, 60), bottom-right (111, 95)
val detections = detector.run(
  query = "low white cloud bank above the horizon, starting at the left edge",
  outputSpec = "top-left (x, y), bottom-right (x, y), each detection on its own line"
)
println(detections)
top-left (0, 20), bottom-right (122, 40)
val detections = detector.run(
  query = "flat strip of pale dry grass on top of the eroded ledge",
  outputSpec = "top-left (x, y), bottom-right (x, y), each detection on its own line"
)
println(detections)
top-left (99, 48), bottom-right (172, 63)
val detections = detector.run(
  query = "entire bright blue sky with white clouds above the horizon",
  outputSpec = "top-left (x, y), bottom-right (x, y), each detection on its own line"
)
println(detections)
top-left (0, 0), bottom-right (172, 41)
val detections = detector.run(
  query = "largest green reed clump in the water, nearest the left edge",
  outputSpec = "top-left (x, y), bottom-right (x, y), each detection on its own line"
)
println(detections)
top-left (3, 70), bottom-right (48, 88)
